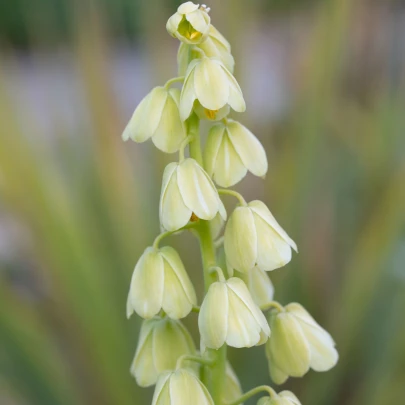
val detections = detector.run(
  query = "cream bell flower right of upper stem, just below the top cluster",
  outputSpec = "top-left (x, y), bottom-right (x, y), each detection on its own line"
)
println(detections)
top-left (204, 119), bottom-right (268, 187)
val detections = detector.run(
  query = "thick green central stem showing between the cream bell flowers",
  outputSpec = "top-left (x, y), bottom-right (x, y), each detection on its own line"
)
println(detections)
top-left (187, 113), bottom-right (226, 405)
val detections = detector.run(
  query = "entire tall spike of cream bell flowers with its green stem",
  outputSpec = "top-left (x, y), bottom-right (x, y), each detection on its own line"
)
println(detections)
top-left (122, 1), bottom-right (338, 405)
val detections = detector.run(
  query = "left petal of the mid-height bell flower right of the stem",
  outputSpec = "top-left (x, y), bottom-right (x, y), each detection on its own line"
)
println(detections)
top-left (224, 207), bottom-right (257, 273)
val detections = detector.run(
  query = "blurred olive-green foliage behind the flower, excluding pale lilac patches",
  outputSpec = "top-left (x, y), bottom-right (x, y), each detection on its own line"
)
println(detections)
top-left (0, 0), bottom-right (405, 405)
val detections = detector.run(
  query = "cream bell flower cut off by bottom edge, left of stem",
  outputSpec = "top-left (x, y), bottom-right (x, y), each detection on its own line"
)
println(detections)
top-left (152, 368), bottom-right (214, 405)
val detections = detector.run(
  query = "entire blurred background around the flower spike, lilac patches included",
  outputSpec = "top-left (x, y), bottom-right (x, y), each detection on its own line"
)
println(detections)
top-left (0, 0), bottom-right (405, 405)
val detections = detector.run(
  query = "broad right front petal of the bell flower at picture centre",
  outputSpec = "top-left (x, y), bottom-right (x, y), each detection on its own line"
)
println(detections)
top-left (177, 158), bottom-right (219, 220)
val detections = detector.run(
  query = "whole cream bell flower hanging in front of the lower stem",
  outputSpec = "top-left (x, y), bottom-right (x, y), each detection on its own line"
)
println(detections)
top-left (198, 277), bottom-right (270, 349)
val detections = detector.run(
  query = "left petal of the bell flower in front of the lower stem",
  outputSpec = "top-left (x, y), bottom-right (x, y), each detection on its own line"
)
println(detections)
top-left (198, 282), bottom-right (229, 349)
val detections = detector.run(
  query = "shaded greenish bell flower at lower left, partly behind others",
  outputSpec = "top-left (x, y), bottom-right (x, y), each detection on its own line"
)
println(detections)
top-left (131, 317), bottom-right (195, 387)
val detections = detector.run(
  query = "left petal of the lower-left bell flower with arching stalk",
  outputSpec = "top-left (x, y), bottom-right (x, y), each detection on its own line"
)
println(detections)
top-left (127, 247), bottom-right (164, 319)
